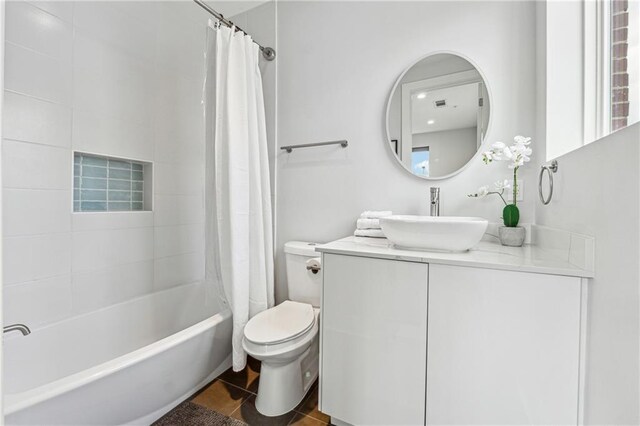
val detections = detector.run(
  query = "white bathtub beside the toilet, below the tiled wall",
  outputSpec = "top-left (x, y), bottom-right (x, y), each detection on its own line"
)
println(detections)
top-left (4, 284), bottom-right (232, 425)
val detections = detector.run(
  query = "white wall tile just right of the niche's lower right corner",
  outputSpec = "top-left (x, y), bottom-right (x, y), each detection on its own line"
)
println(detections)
top-left (154, 194), bottom-right (204, 226)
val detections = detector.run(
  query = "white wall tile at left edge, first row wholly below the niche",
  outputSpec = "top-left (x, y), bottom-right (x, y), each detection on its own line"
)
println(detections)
top-left (3, 233), bottom-right (71, 285)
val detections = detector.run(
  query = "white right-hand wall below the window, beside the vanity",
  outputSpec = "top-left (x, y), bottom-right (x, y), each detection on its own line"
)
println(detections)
top-left (536, 123), bottom-right (640, 425)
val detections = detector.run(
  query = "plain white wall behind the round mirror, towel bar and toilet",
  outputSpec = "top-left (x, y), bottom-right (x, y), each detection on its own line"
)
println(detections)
top-left (276, 1), bottom-right (537, 300)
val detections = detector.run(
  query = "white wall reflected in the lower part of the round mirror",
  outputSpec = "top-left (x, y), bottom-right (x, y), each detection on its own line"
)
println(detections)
top-left (413, 127), bottom-right (478, 176)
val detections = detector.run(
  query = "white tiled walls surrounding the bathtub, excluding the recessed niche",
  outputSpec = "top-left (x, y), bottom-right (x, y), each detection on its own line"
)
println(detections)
top-left (2, 1), bottom-right (208, 328)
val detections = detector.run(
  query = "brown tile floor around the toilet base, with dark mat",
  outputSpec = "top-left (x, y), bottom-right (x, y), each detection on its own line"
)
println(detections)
top-left (156, 358), bottom-right (330, 426)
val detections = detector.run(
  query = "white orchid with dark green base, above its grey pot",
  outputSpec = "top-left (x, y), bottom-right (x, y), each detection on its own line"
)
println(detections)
top-left (468, 136), bottom-right (533, 227)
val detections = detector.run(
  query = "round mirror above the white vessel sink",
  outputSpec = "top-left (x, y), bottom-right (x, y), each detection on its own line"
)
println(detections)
top-left (387, 53), bottom-right (490, 179)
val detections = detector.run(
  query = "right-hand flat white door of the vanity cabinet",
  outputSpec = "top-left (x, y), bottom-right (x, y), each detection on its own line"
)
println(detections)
top-left (427, 265), bottom-right (581, 425)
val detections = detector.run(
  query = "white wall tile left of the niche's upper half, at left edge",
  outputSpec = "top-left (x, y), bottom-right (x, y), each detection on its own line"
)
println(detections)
top-left (2, 139), bottom-right (73, 191)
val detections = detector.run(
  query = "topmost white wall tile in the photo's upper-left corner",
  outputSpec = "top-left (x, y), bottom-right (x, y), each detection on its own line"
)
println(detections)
top-left (5, 1), bottom-right (73, 62)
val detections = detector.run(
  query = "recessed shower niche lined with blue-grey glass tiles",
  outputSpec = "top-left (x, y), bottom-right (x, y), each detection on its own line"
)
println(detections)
top-left (73, 152), bottom-right (150, 212)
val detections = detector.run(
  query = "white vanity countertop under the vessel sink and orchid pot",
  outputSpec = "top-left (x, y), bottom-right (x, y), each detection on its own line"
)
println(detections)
top-left (316, 236), bottom-right (593, 278)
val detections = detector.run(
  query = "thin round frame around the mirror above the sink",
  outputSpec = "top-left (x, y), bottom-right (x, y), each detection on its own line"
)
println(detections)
top-left (384, 50), bottom-right (494, 181)
